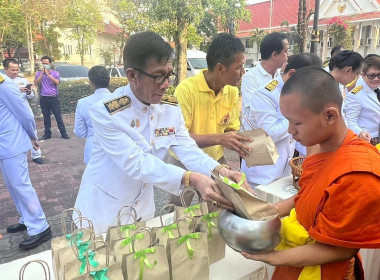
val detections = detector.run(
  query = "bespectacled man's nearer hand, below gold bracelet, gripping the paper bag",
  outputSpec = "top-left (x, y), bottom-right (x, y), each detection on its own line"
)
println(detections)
top-left (190, 172), bottom-right (233, 210)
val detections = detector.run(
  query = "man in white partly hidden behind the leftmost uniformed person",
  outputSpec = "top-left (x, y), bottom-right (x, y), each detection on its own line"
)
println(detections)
top-left (3, 58), bottom-right (44, 164)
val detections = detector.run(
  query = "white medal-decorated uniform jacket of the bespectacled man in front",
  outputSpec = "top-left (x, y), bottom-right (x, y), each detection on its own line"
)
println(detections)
top-left (75, 85), bottom-right (219, 234)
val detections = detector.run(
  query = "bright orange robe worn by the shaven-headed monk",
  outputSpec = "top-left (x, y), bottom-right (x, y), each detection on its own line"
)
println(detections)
top-left (272, 130), bottom-right (380, 280)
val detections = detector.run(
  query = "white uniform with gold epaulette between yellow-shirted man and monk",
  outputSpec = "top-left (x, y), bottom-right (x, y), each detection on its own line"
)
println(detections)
top-left (241, 75), bottom-right (296, 186)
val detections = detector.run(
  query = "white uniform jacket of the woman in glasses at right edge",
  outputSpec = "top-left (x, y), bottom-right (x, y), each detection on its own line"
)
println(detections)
top-left (344, 77), bottom-right (380, 142)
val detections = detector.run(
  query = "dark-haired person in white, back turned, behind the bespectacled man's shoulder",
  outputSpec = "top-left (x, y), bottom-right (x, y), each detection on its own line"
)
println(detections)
top-left (74, 65), bottom-right (111, 164)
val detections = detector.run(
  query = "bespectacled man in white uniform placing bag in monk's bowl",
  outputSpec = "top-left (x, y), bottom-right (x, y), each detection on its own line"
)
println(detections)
top-left (75, 32), bottom-right (248, 234)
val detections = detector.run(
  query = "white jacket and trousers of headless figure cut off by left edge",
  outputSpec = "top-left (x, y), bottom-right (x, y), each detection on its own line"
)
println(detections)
top-left (0, 77), bottom-right (48, 235)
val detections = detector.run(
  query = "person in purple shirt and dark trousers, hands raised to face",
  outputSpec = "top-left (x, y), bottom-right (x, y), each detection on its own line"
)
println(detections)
top-left (34, 56), bottom-right (70, 140)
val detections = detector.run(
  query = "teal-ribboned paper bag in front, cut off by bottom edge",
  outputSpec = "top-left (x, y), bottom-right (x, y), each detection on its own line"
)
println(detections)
top-left (72, 241), bottom-right (124, 280)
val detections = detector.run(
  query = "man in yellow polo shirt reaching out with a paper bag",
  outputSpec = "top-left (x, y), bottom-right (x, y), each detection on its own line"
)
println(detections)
top-left (168, 33), bottom-right (252, 205)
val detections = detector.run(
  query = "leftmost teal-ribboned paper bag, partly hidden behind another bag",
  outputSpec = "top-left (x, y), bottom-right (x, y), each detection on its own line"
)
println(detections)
top-left (51, 208), bottom-right (83, 279)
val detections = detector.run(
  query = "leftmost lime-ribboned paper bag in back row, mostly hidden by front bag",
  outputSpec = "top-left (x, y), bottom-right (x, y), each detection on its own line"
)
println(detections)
top-left (105, 206), bottom-right (145, 252)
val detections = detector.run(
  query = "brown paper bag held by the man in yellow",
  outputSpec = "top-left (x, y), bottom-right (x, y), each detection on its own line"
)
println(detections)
top-left (238, 116), bottom-right (280, 167)
